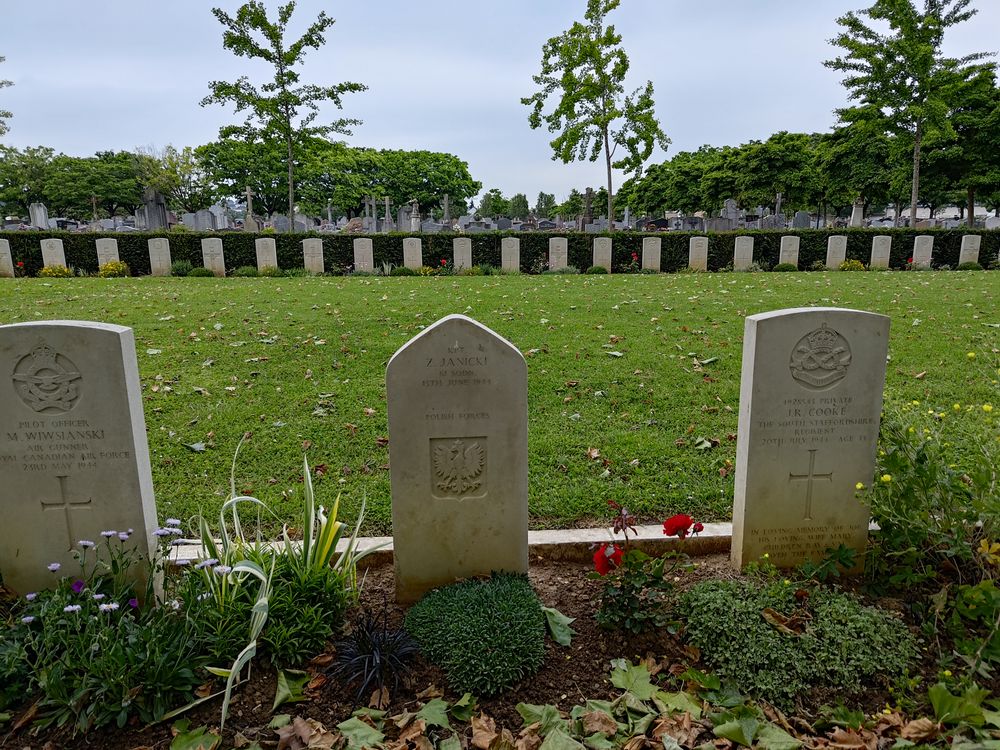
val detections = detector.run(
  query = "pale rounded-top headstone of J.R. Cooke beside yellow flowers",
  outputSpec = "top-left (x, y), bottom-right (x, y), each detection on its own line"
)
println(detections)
top-left (732, 308), bottom-right (889, 568)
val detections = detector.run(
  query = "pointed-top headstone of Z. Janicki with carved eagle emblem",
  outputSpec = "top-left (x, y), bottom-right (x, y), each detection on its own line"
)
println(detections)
top-left (386, 315), bottom-right (528, 602)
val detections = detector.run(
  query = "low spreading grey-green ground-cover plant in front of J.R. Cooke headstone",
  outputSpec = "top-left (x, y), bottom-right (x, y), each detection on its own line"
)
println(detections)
top-left (680, 581), bottom-right (917, 709)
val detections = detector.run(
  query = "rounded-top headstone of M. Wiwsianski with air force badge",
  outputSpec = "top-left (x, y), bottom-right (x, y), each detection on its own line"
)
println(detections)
top-left (0, 321), bottom-right (156, 593)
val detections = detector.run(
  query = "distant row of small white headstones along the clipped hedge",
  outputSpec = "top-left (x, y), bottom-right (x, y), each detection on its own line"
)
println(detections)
top-left (0, 234), bottom-right (982, 277)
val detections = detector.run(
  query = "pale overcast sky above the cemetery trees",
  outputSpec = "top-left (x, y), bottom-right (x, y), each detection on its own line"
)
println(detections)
top-left (0, 0), bottom-right (1000, 203)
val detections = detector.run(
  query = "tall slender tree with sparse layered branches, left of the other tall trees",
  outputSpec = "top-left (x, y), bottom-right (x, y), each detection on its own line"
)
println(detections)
top-left (201, 0), bottom-right (366, 231)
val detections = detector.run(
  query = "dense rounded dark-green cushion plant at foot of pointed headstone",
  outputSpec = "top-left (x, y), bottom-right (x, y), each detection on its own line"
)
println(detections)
top-left (405, 573), bottom-right (545, 698)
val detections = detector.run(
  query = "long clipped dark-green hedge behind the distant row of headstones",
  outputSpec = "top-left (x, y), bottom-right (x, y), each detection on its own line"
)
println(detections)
top-left (0, 229), bottom-right (1000, 276)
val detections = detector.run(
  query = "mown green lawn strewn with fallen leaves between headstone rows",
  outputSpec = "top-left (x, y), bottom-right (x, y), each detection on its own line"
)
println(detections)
top-left (0, 272), bottom-right (1000, 533)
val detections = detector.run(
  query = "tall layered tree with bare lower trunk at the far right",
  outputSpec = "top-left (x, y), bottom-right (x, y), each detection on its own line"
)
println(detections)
top-left (824, 0), bottom-right (988, 226)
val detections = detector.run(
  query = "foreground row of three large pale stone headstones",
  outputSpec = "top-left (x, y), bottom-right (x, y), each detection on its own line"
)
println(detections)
top-left (0, 308), bottom-right (889, 602)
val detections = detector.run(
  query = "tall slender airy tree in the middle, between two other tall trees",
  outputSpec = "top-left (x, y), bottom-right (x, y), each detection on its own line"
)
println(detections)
top-left (521, 0), bottom-right (669, 228)
